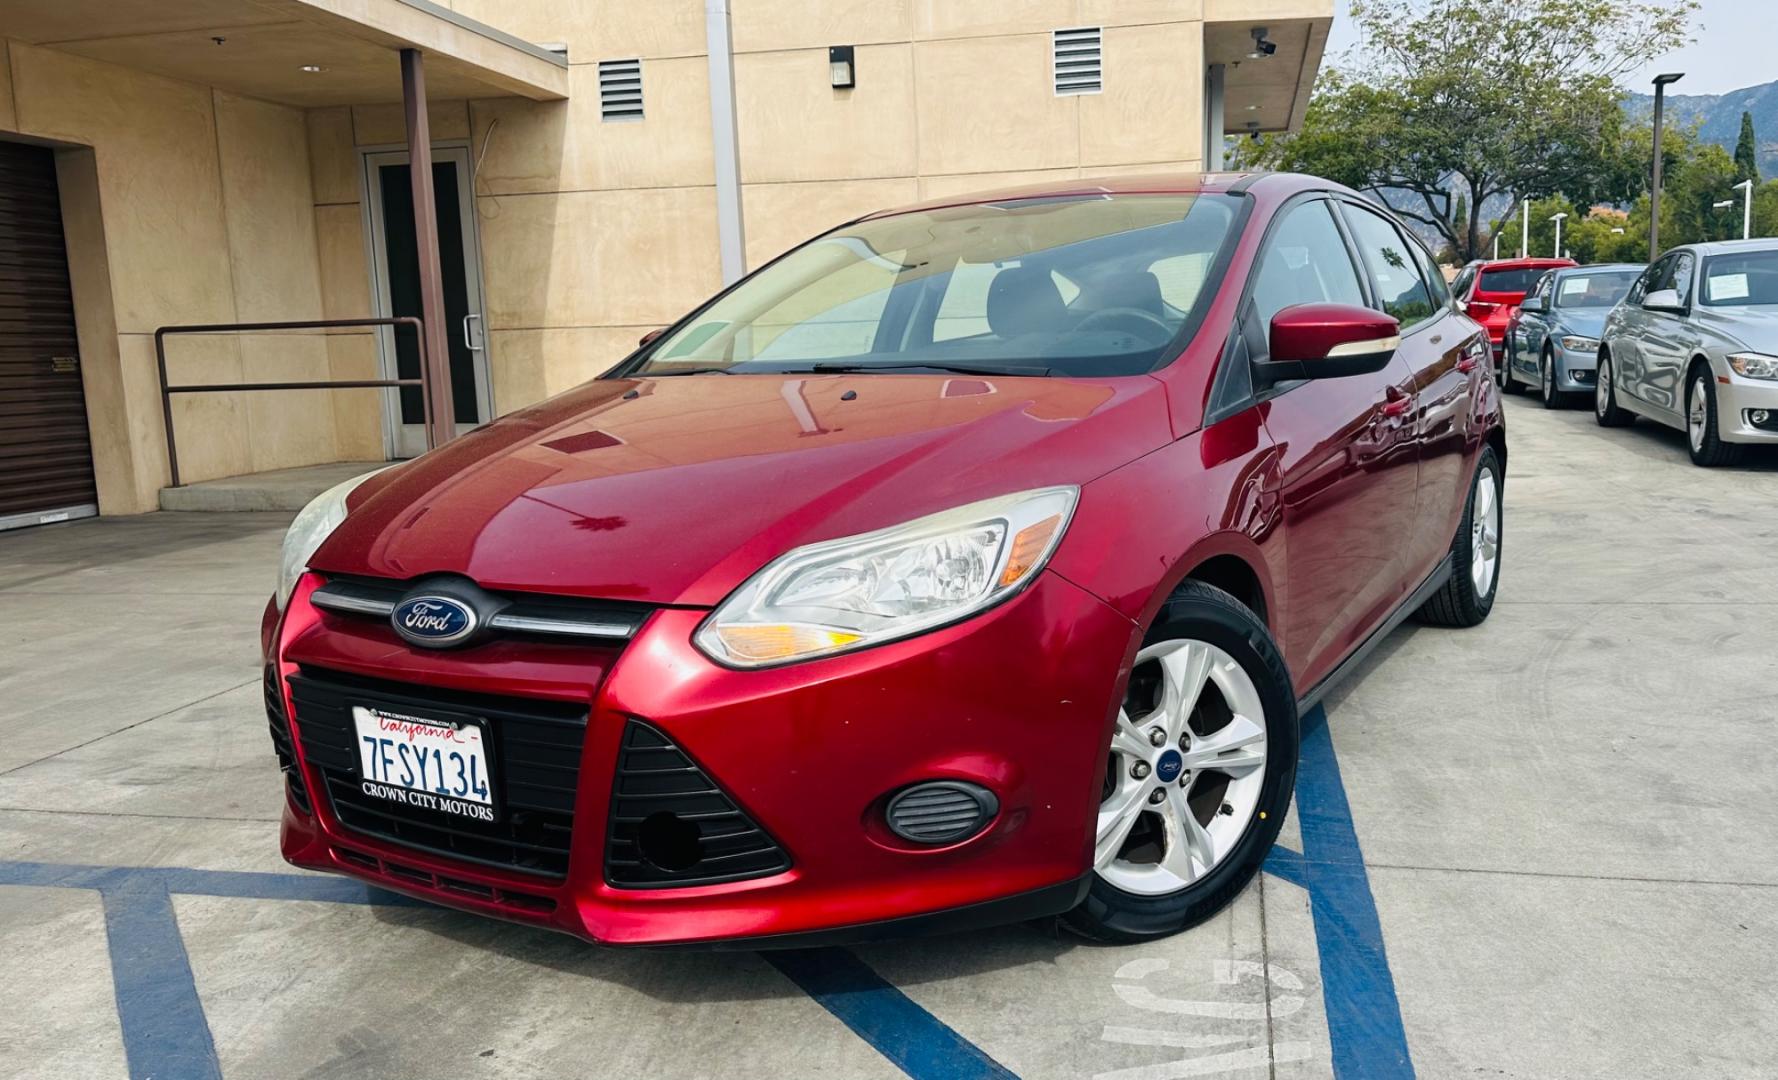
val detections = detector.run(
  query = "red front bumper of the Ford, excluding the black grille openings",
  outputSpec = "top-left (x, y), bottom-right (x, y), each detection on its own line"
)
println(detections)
top-left (274, 573), bottom-right (1138, 945)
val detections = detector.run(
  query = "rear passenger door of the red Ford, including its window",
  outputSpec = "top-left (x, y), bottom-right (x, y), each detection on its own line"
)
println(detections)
top-left (1341, 203), bottom-right (1488, 594)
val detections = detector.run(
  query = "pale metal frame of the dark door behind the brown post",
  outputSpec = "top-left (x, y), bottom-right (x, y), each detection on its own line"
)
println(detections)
top-left (354, 139), bottom-right (494, 461)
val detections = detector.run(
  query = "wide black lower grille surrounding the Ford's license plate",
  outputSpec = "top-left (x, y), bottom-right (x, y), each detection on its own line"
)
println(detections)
top-left (290, 667), bottom-right (587, 877)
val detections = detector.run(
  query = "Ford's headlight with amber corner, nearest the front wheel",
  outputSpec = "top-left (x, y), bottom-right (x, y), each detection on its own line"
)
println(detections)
top-left (697, 488), bottom-right (1079, 667)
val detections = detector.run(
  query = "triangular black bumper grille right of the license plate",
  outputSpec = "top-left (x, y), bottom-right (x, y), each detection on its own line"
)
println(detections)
top-left (605, 721), bottom-right (789, 888)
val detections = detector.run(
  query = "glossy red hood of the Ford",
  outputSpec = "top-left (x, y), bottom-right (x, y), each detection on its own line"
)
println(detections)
top-left (311, 374), bottom-right (1172, 605)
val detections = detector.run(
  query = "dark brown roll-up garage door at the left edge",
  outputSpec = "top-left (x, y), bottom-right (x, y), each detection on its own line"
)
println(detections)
top-left (0, 142), bottom-right (98, 528)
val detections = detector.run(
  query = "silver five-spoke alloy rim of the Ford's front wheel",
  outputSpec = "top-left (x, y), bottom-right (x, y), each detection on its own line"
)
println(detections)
top-left (1093, 639), bottom-right (1266, 897)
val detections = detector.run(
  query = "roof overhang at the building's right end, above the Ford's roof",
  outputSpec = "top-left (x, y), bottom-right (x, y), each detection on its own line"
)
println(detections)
top-left (1204, 0), bottom-right (1334, 135)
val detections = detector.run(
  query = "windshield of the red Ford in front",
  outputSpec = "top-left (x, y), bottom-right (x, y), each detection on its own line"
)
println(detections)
top-left (619, 194), bottom-right (1241, 375)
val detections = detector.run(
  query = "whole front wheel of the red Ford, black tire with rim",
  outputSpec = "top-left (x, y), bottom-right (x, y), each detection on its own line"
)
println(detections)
top-left (1061, 580), bottom-right (1298, 945)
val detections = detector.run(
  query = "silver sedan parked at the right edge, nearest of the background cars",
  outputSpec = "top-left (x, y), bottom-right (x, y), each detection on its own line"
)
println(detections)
top-left (1593, 240), bottom-right (1778, 464)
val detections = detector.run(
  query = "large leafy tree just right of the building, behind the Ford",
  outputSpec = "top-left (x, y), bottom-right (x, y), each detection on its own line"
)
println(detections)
top-left (1243, 0), bottom-right (1698, 260)
